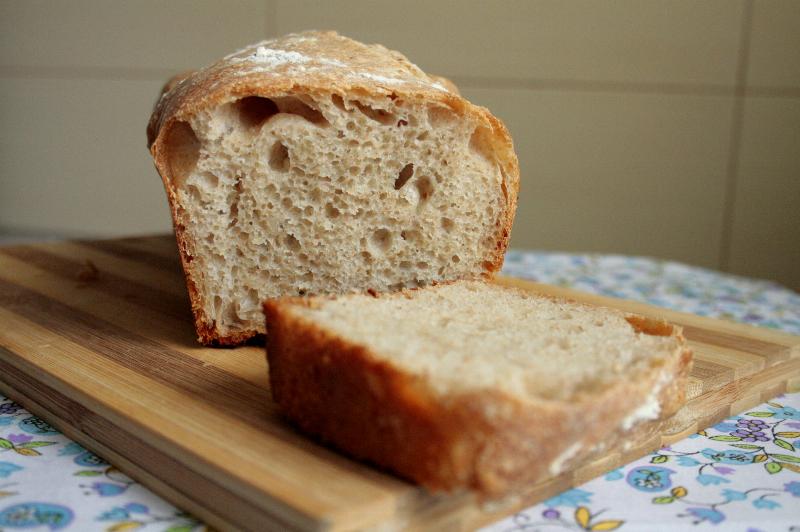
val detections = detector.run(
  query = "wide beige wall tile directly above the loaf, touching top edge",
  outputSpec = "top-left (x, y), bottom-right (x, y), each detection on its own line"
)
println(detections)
top-left (276, 0), bottom-right (742, 85)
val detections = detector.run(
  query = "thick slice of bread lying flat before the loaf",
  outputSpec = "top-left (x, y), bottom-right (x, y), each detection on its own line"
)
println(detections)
top-left (264, 281), bottom-right (691, 498)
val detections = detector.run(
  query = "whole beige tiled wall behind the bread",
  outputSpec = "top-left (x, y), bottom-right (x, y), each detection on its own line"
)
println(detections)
top-left (0, 0), bottom-right (800, 288)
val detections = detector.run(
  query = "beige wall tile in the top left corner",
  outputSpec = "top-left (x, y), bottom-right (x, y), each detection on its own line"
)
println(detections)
top-left (0, 0), bottom-right (268, 70)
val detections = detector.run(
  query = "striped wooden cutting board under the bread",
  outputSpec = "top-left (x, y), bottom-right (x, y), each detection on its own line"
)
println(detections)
top-left (0, 237), bottom-right (800, 530)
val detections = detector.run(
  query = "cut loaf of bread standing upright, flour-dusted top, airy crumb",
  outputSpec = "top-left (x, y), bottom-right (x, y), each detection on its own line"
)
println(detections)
top-left (148, 32), bottom-right (519, 344)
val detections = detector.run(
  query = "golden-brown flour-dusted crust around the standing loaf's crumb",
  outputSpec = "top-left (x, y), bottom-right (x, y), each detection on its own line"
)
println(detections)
top-left (147, 32), bottom-right (519, 345)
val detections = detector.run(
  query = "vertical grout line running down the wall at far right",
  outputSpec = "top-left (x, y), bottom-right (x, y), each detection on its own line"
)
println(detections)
top-left (719, 0), bottom-right (753, 272)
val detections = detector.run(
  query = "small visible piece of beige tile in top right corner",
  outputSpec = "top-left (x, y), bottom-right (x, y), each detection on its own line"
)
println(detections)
top-left (747, 0), bottom-right (800, 89)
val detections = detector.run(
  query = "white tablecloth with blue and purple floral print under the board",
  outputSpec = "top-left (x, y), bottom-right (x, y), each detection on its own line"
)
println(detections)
top-left (0, 251), bottom-right (800, 532)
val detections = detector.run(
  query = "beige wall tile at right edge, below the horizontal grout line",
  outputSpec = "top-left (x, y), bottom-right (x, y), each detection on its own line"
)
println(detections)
top-left (730, 98), bottom-right (800, 291)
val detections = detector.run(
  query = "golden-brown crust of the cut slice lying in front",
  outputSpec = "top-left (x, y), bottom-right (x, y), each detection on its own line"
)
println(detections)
top-left (264, 294), bottom-right (691, 499)
